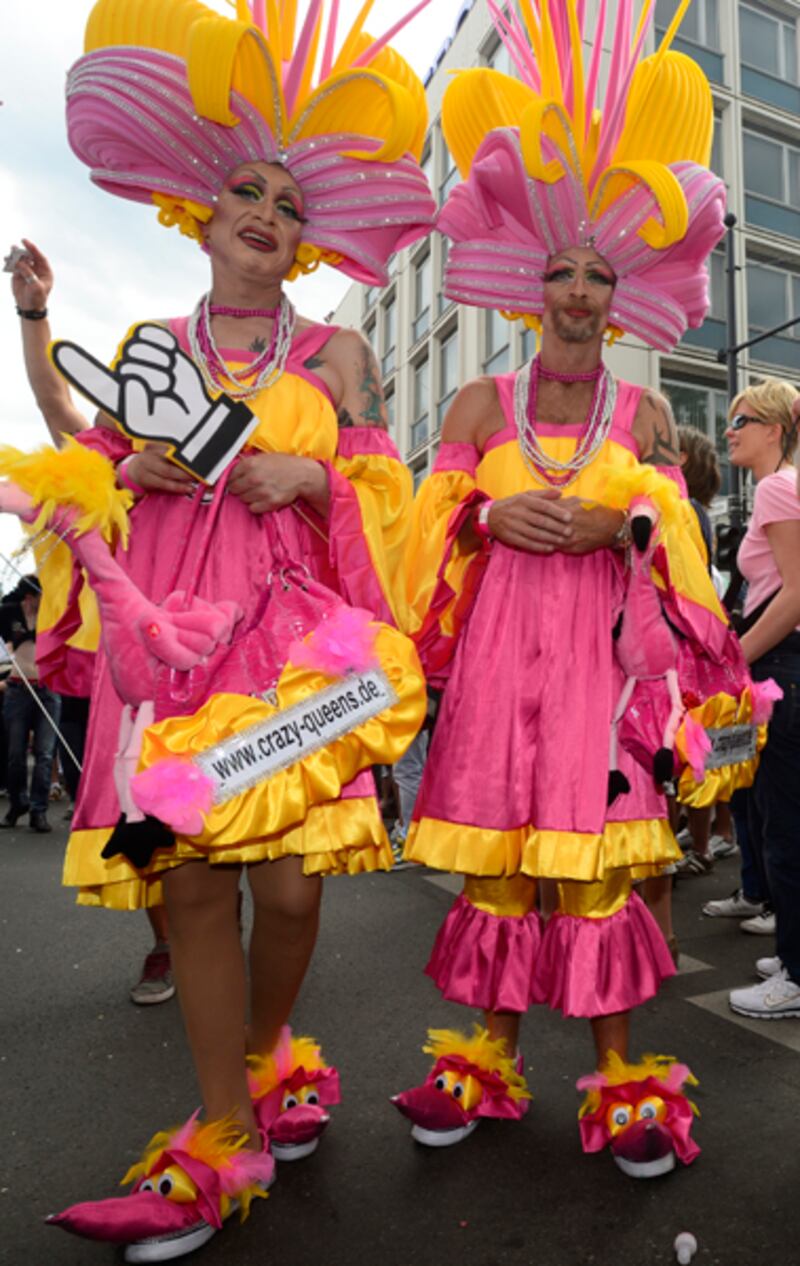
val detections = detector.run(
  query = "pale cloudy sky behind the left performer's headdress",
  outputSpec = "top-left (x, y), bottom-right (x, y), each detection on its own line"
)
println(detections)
top-left (0, 0), bottom-right (462, 574)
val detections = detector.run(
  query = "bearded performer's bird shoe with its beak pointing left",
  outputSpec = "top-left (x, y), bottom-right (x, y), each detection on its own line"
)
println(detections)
top-left (391, 1024), bottom-right (530, 1147)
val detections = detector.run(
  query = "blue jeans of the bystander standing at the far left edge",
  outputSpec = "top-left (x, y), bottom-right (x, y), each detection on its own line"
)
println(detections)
top-left (3, 681), bottom-right (61, 813)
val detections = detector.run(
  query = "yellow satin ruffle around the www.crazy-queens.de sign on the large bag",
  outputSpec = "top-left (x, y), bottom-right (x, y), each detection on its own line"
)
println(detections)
top-left (139, 624), bottom-right (427, 851)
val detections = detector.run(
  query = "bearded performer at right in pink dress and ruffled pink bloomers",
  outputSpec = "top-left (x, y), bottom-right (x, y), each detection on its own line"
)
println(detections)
top-left (395, 0), bottom-right (754, 1176)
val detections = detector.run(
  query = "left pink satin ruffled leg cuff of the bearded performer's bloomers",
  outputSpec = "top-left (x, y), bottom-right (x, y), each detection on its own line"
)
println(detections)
top-left (425, 895), bottom-right (542, 1013)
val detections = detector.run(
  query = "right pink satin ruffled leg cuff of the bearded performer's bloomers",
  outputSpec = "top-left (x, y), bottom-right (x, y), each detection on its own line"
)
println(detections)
top-left (532, 893), bottom-right (675, 1017)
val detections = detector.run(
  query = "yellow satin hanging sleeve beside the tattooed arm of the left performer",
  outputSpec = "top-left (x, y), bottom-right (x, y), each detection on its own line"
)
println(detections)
top-left (333, 453), bottom-right (413, 629)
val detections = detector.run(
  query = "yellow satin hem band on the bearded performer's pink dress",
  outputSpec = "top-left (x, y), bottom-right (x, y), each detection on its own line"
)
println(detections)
top-left (404, 818), bottom-right (681, 882)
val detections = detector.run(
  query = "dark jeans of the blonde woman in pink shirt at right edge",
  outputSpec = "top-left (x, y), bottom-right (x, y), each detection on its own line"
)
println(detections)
top-left (748, 638), bottom-right (800, 985)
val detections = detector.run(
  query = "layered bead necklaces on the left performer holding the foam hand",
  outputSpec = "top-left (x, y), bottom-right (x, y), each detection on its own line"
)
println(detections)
top-left (187, 295), bottom-right (297, 400)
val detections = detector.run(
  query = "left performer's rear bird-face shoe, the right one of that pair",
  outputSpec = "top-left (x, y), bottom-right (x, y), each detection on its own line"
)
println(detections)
top-left (247, 1028), bottom-right (339, 1161)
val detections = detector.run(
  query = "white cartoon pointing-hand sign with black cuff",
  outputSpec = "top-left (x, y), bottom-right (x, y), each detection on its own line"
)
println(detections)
top-left (49, 324), bottom-right (258, 484)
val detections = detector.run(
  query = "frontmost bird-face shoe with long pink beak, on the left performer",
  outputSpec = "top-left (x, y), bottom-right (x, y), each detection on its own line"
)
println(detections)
top-left (47, 1113), bottom-right (275, 1262)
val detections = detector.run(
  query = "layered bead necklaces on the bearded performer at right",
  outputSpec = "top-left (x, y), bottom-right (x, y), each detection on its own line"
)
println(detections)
top-left (514, 356), bottom-right (616, 487)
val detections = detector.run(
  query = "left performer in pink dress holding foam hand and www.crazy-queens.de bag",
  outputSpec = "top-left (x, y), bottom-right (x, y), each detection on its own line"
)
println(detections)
top-left (3, 0), bottom-right (434, 1261)
